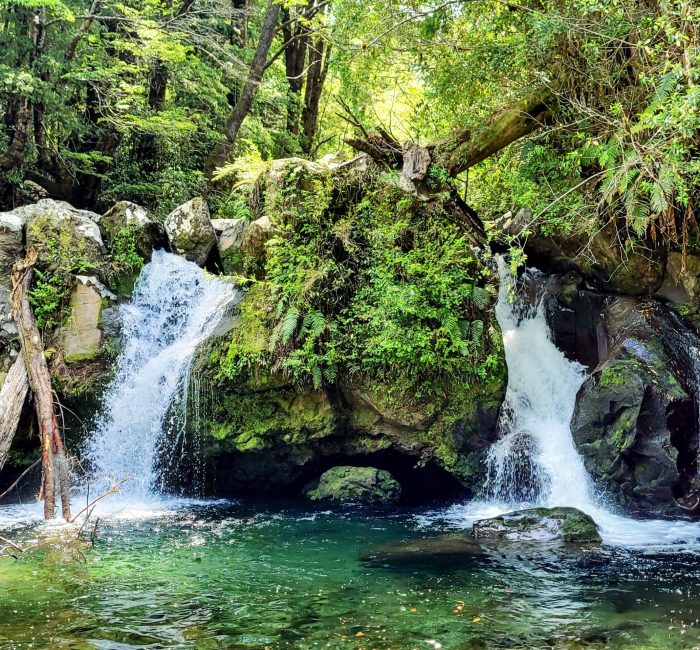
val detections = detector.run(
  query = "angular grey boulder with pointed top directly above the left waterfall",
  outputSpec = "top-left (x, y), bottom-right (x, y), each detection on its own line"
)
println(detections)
top-left (165, 197), bottom-right (216, 266)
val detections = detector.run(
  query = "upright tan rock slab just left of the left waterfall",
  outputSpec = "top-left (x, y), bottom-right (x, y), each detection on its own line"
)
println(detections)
top-left (58, 275), bottom-right (114, 363)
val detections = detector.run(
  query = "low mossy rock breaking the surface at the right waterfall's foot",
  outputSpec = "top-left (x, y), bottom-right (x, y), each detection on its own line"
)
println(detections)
top-left (474, 508), bottom-right (601, 544)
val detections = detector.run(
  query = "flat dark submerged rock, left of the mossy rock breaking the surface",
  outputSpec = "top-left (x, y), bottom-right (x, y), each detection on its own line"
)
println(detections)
top-left (360, 535), bottom-right (483, 564)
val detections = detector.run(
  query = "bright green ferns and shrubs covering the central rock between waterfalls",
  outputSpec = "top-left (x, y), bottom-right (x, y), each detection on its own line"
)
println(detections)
top-left (220, 165), bottom-right (502, 395)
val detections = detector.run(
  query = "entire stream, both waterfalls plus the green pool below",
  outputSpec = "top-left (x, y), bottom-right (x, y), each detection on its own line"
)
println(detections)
top-left (0, 253), bottom-right (700, 650)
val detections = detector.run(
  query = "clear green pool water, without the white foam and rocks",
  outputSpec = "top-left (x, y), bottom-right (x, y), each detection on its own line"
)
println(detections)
top-left (0, 501), bottom-right (700, 650)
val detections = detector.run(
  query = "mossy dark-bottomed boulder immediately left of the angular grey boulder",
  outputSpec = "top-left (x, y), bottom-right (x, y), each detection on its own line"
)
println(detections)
top-left (96, 201), bottom-right (168, 259)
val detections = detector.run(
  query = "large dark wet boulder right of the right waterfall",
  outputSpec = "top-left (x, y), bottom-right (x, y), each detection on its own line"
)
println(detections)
top-left (571, 297), bottom-right (698, 515)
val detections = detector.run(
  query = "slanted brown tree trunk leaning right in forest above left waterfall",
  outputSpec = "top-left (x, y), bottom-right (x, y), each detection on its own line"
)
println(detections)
top-left (204, 0), bottom-right (280, 181)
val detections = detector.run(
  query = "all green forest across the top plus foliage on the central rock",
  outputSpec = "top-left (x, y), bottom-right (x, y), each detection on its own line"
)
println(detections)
top-left (0, 0), bottom-right (700, 392)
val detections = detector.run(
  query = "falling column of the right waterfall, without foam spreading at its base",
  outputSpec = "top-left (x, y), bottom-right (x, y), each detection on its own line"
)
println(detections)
top-left (486, 257), bottom-right (592, 510)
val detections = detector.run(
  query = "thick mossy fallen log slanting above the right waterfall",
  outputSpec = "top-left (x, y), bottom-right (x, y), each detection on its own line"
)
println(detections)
top-left (432, 89), bottom-right (554, 176)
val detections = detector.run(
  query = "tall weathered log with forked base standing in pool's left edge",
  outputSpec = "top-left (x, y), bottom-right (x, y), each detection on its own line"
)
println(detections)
top-left (12, 246), bottom-right (71, 521)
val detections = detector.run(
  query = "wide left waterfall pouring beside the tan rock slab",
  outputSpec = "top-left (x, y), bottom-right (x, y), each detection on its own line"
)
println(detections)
top-left (85, 251), bottom-right (240, 499)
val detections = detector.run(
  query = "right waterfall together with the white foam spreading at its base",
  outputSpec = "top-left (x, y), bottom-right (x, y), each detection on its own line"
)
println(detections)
top-left (422, 258), bottom-right (700, 548)
